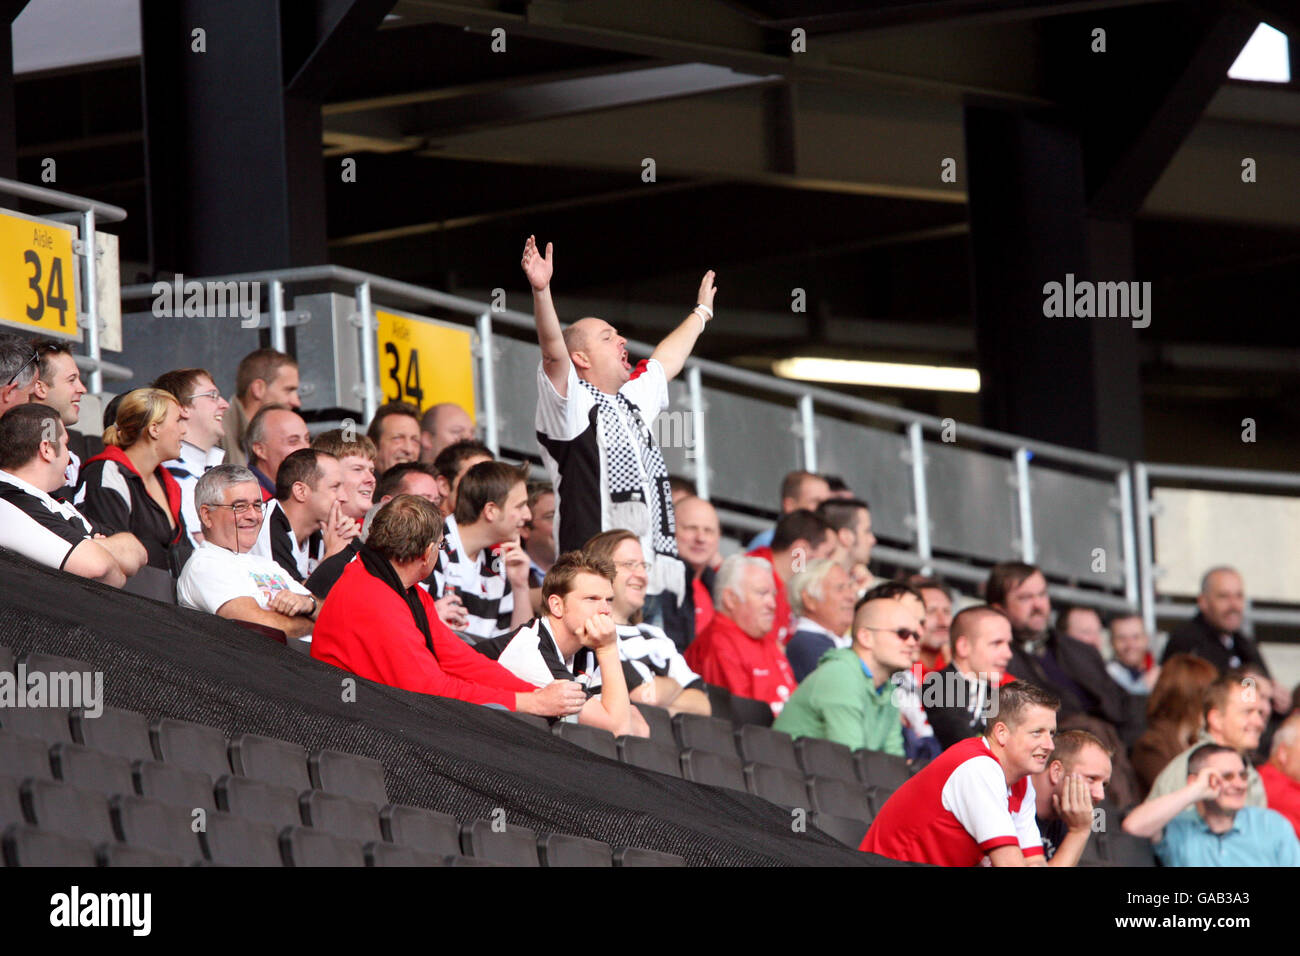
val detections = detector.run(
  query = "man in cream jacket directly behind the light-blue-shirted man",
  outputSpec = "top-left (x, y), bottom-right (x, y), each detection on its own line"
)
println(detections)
top-left (1147, 670), bottom-right (1273, 806)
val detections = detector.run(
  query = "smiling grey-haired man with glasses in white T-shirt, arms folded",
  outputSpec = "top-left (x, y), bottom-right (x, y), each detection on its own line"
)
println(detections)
top-left (176, 464), bottom-right (320, 637)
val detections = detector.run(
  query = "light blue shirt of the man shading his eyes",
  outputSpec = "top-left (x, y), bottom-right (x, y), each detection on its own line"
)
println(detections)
top-left (1156, 806), bottom-right (1300, 866)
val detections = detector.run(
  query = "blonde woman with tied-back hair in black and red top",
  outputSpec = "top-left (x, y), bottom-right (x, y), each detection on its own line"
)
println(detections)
top-left (75, 389), bottom-right (194, 578)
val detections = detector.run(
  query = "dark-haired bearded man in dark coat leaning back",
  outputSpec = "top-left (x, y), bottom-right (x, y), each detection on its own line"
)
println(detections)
top-left (984, 562), bottom-right (1144, 745)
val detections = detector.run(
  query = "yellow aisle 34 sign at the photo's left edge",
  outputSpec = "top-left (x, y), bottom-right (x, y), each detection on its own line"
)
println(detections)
top-left (0, 209), bottom-right (81, 338)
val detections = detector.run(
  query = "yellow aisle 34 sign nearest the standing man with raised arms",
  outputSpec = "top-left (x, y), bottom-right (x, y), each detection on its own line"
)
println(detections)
top-left (374, 310), bottom-right (475, 418)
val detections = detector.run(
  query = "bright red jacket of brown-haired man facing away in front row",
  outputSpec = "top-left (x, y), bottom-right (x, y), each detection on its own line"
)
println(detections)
top-left (312, 558), bottom-right (537, 710)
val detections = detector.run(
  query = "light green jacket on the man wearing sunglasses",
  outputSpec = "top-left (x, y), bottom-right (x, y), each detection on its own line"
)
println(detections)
top-left (772, 648), bottom-right (904, 757)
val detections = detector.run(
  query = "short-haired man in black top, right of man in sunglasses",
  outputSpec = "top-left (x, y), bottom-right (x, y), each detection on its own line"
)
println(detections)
top-left (922, 605), bottom-right (1011, 749)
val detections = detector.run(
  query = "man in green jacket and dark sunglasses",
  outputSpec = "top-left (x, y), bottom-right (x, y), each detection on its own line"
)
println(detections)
top-left (772, 583), bottom-right (926, 757)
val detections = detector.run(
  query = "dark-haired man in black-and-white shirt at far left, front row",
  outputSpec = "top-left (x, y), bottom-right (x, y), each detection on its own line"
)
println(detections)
top-left (0, 403), bottom-right (148, 588)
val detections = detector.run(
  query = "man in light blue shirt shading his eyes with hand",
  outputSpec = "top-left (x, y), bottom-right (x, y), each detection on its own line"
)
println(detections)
top-left (1123, 744), bottom-right (1300, 866)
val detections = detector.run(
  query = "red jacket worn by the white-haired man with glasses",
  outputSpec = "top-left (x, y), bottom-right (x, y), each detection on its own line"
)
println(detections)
top-left (683, 611), bottom-right (797, 714)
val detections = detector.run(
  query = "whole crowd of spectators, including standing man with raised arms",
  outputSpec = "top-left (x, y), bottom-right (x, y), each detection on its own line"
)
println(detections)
top-left (0, 237), bottom-right (1300, 866)
